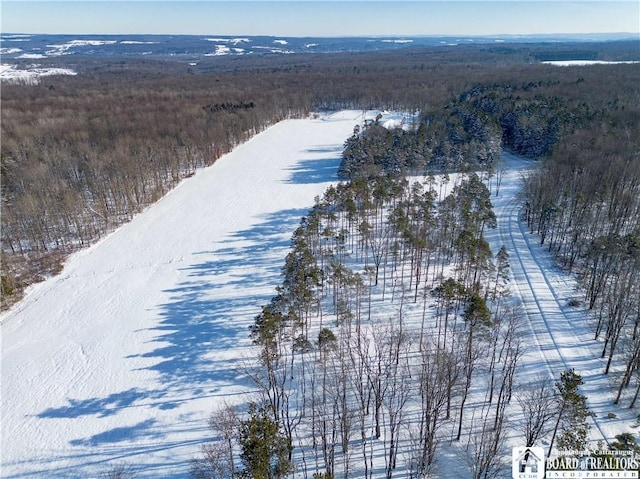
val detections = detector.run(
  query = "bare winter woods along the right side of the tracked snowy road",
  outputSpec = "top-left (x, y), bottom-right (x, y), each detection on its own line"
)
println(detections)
top-left (522, 107), bottom-right (640, 408)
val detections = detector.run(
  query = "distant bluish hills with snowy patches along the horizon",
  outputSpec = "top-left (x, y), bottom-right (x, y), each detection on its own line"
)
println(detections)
top-left (0, 33), bottom-right (638, 62)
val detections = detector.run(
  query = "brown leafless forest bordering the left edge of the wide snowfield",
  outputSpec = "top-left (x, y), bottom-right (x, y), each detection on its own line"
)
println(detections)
top-left (1, 71), bottom-right (308, 305)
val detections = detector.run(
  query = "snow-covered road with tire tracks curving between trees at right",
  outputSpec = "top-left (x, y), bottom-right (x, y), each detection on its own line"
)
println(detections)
top-left (490, 153), bottom-right (635, 450)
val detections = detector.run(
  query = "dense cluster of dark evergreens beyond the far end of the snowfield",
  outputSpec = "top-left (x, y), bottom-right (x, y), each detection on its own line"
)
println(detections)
top-left (339, 78), bottom-right (605, 178)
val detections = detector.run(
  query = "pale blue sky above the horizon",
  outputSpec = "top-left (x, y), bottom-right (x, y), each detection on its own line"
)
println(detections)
top-left (0, 0), bottom-right (640, 37)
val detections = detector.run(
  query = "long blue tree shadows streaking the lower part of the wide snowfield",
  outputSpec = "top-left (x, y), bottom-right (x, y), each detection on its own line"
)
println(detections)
top-left (27, 209), bottom-right (307, 478)
